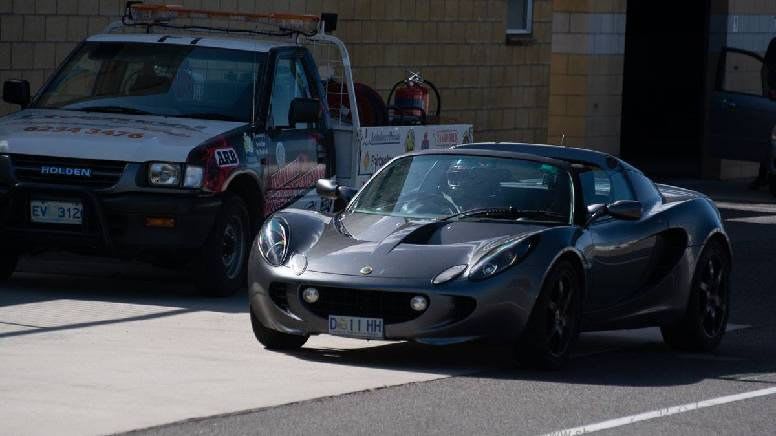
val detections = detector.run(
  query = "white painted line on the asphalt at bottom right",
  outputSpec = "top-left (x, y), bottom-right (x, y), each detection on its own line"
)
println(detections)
top-left (545, 387), bottom-right (776, 436)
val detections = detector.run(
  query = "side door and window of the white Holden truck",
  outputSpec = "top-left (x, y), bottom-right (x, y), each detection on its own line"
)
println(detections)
top-left (265, 49), bottom-right (330, 214)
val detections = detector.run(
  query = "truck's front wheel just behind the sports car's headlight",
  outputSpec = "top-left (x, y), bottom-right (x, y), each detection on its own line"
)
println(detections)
top-left (194, 193), bottom-right (253, 297)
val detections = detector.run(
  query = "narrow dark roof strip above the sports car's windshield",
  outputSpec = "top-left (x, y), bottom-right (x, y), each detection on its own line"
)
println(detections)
top-left (453, 142), bottom-right (638, 172)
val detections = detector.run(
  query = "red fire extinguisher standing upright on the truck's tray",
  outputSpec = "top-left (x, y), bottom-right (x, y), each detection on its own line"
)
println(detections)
top-left (388, 71), bottom-right (442, 126)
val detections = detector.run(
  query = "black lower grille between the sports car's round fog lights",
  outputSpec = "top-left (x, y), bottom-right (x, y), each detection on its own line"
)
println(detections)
top-left (300, 287), bottom-right (423, 324)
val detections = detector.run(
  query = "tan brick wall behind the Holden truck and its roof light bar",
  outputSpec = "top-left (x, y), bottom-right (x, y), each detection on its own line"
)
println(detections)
top-left (0, 0), bottom-right (552, 142)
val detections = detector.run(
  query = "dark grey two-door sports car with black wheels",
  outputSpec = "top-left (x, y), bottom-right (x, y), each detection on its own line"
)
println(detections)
top-left (249, 143), bottom-right (731, 368)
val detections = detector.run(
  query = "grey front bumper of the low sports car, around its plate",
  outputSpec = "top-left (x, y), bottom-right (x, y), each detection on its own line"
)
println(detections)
top-left (248, 244), bottom-right (540, 344)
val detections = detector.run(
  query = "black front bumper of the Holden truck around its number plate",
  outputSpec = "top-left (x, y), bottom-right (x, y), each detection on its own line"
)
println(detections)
top-left (0, 183), bottom-right (221, 256)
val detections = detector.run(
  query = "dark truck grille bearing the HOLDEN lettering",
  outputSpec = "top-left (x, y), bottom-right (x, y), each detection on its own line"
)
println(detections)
top-left (11, 155), bottom-right (127, 189)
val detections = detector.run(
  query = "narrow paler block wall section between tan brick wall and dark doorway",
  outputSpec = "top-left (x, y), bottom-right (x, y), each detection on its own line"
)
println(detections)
top-left (548, 0), bottom-right (626, 154)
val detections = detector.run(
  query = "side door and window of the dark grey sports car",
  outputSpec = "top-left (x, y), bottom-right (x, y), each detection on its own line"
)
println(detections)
top-left (579, 169), bottom-right (667, 310)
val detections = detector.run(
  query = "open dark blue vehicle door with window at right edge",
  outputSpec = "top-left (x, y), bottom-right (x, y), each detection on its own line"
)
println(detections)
top-left (709, 44), bottom-right (776, 162)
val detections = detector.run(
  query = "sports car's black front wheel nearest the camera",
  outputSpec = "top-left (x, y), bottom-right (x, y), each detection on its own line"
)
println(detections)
top-left (515, 261), bottom-right (583, 370)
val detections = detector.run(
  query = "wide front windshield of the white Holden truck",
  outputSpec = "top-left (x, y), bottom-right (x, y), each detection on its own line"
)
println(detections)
top-left (35, 42), bottom-right (265, 122)
